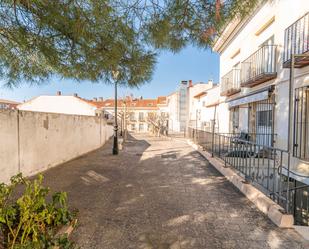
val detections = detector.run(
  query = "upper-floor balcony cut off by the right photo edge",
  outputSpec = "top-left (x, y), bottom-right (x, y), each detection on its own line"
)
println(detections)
top-left (283, 13), bottom-right (309, 68)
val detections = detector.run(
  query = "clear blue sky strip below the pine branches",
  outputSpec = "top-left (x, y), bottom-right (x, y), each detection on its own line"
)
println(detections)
top-left (0, 47), bottom-right (219, 101)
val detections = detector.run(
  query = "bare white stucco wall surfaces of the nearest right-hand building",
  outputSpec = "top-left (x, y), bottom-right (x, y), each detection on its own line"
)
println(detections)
top-left (215, 0), bottom-right (309, 171)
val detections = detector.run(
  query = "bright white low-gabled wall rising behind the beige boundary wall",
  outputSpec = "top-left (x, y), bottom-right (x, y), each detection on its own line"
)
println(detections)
top-left (17, 96), bottom-right (97, 116)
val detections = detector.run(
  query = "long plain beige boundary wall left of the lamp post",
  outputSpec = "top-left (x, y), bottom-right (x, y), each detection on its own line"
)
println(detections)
top-left (0, 110), bottom-right (113, 182)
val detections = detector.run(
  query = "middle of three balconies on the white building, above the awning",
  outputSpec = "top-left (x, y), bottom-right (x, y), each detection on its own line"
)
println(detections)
top-left (240, 45), bottom-right (277, 87)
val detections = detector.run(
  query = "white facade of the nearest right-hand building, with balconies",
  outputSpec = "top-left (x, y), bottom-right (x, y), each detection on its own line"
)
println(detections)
top-left (213, 0), bottom-right (309, 175)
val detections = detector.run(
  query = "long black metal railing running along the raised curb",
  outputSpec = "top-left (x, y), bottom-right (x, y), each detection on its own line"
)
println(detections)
top-left (187, 128), bottom-right (309, 226)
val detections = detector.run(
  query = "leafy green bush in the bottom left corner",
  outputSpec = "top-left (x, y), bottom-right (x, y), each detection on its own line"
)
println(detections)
top-left (0, 174), bottom-right (74, 249)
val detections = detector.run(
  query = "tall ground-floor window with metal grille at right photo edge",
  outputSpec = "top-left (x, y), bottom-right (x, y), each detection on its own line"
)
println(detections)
top-left (293, 86), bottom-right (309, 160)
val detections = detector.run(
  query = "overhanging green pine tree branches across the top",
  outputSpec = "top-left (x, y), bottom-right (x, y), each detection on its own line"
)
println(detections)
top-left (0, 0), bottom-right (260, 86)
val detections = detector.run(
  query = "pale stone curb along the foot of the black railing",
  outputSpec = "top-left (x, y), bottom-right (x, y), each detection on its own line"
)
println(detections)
top-left (187, 139), bottom-right (294, 228)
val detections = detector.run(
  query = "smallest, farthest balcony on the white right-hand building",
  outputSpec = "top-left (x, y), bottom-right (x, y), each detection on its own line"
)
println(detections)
top-left (220, 68), bottom-right (240, 96)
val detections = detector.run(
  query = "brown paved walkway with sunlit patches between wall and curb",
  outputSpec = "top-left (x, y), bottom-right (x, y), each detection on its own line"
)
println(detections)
top-left (45, 135), bottom-right (307, 249)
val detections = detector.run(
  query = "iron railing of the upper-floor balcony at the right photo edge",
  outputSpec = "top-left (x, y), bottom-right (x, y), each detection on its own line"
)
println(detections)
top-left (283, 12), bottom-right (309, 63)
